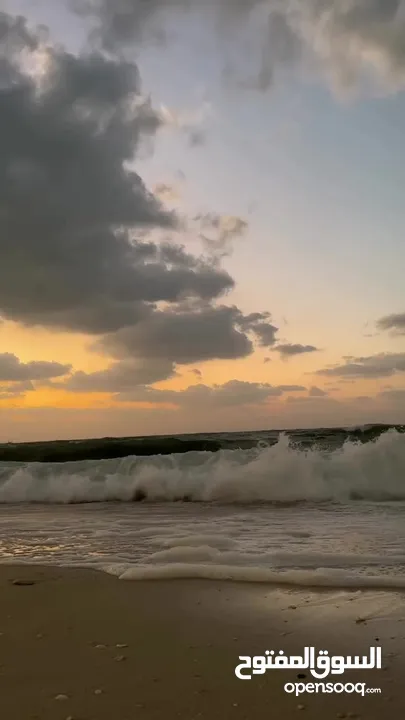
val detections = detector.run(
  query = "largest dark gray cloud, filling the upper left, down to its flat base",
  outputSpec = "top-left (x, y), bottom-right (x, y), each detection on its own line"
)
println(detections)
top-left (0, 13), bottom-right (233, 334)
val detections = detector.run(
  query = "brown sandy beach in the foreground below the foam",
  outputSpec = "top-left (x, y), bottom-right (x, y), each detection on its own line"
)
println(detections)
top-left (0, 566), bottom-right (405, 720)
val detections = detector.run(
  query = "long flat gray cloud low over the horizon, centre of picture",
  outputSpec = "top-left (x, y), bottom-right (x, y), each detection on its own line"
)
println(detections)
top-left (117, 380), bottom-right (305, 409)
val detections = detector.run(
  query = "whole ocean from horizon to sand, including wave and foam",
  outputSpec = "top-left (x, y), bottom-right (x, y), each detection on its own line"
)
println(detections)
top-left (0, 425), bottom-right (405, 589)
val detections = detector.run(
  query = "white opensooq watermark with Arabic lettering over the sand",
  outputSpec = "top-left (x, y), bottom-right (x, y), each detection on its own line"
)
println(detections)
top-left (235, 647), bottom-right (382, 696)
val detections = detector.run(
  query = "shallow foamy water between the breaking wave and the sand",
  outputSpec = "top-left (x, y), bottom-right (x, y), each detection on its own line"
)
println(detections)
top-left (0, 503), bottom-right (405, 589)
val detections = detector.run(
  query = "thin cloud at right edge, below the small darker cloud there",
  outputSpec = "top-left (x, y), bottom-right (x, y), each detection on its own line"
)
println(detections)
top-left (316, 353), bottom-right (405, 378)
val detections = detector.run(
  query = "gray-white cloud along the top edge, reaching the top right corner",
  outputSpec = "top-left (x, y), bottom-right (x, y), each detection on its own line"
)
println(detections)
top-left (70, 0), bottom-right (405, 91)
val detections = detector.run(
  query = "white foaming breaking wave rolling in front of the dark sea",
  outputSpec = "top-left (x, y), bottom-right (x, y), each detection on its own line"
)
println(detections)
top-left (0, 430), bottom-right (405, 504)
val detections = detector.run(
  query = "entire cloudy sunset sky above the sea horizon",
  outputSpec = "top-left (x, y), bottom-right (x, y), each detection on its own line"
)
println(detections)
top-left (0, 0), bottom-right (405, 442)
